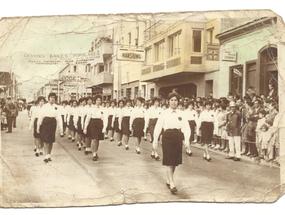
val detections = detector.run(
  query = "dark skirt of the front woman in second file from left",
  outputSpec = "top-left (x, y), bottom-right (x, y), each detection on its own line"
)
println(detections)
top-left (87, 118), bottom-right (104, 140)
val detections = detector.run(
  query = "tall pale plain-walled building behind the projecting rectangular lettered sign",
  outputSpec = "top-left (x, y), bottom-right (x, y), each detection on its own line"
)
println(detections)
top-left (113, 20), bottom-right (146, 99)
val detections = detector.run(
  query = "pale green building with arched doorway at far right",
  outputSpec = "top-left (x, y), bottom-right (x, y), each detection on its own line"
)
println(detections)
top-left (217, 17), bottom-right (280, 96)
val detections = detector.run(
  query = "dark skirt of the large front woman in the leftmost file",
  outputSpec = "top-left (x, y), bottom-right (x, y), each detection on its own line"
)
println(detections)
top-left (40, 117), bottom-right (56, 143)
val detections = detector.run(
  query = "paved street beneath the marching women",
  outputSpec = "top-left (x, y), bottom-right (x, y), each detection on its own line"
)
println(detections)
top-left (1, 112), bottom-right (280, 206)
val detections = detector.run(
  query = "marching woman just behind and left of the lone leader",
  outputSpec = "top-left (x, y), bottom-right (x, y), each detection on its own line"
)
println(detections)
top-left (144, 98), bottom-right (163, 161)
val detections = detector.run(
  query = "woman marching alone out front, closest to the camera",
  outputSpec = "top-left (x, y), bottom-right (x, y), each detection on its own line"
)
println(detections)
top-left (153, 93), bottom-right (191, 194)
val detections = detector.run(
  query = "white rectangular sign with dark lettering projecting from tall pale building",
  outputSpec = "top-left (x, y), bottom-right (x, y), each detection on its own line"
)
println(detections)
top-left (117, 48), bottom-right (145, 62)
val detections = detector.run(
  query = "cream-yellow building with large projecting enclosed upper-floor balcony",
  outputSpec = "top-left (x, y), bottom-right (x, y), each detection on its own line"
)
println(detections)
top-left (141, 19), bottom-right (221, 98)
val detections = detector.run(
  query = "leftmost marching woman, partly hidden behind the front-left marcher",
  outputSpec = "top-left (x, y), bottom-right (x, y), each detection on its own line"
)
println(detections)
top-left (29, 96), bottom-right (46, 157)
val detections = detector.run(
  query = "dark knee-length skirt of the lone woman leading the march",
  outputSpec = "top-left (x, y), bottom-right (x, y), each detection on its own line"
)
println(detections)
top-left (162, 129), bottom-right (184, 166)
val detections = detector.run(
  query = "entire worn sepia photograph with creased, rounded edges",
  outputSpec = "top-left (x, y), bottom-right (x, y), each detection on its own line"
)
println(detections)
top-left (0, 7), bottom-right (285, 208)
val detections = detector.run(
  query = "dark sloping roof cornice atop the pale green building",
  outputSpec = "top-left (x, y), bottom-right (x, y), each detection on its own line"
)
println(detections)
top-left (216, 16), bottom-right (277, 42)
